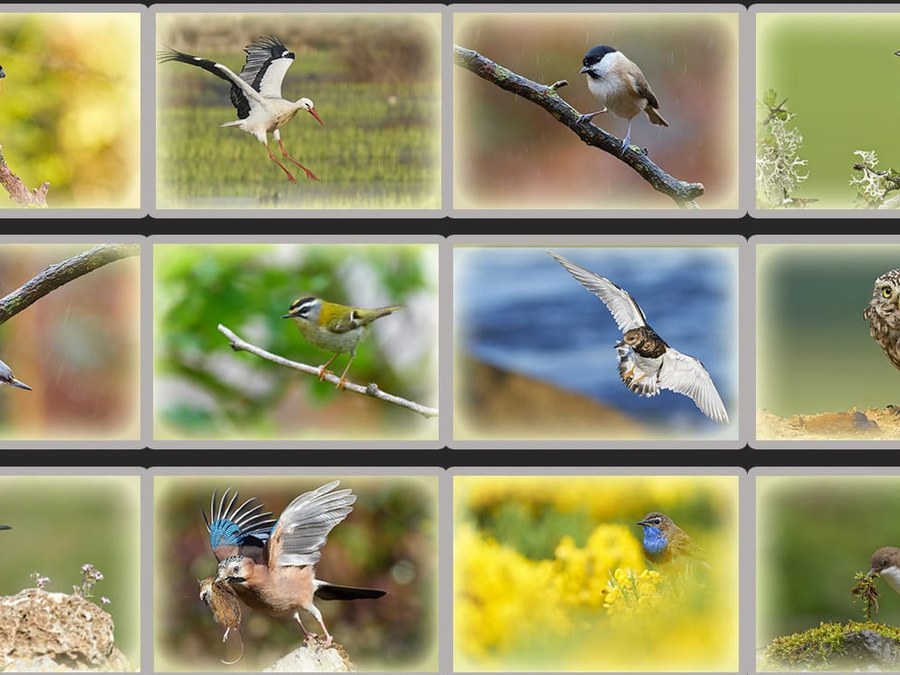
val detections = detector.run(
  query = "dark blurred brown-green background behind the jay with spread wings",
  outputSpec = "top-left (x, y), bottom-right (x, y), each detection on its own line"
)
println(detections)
top-left (154, 476), bottom-right (438, 672)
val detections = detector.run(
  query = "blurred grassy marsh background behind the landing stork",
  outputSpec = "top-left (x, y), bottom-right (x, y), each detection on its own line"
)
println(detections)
top-left (157, 14), bottom-right (440, 209)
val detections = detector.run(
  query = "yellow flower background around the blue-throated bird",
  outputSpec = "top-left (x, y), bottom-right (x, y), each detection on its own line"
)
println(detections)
top-left (453, 476), bottom-right (738, 672)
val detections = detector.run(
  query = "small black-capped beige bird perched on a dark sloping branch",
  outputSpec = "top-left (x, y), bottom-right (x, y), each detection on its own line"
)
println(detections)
top-left (580, 45), bottom-right (669, 153)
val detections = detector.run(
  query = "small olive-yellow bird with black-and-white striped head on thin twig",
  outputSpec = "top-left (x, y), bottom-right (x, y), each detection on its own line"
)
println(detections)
top-left (281, 297), bottom-right (403, 389)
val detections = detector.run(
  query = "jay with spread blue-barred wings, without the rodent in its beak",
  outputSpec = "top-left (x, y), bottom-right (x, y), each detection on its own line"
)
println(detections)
top-left (204, 481), bottom-right (387, 647)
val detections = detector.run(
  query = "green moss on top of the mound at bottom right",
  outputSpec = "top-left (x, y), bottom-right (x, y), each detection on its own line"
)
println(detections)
top-left (760, 621), bottom-right (900, 670)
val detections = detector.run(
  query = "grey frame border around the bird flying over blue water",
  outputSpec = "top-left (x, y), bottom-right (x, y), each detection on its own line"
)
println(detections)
top-left (441, 235), bottom-right (756, 450)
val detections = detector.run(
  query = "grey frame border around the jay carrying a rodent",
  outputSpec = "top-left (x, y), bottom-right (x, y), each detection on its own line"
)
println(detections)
top-left (151, 466), bottom-right (453, 675)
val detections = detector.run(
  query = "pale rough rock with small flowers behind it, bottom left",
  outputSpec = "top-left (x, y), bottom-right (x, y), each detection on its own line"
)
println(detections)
top-left (0, 588), bottom-right (131, 672)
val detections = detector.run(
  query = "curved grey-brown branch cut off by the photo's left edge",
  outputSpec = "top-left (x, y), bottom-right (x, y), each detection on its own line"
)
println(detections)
top-left (0, 244), bottom-right (141, 324)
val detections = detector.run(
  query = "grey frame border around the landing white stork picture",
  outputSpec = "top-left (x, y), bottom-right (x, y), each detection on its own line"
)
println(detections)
top-left (142, 3), bottom-right (452, 220)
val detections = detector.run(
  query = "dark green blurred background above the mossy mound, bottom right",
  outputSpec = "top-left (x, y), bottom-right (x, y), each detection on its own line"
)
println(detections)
top-left (756, 475), bottom-right (900, 647)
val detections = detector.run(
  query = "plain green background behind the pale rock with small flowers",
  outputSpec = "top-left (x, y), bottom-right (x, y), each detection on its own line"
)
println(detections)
top-left (0, 476), bottom-right (141, 669)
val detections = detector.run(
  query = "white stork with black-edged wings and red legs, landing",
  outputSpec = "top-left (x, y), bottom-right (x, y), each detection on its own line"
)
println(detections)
top-left (156, 35), bottom-right (324, 184)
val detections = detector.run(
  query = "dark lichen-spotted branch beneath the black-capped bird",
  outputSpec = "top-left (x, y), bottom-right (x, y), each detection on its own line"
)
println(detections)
top-left (453, 45), bottom-right (705, 209)
